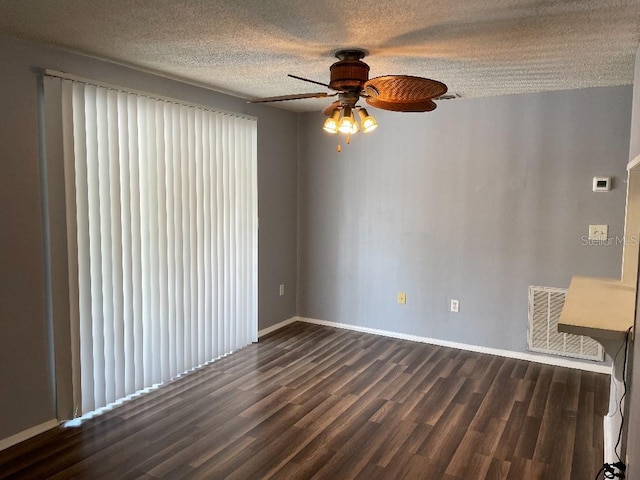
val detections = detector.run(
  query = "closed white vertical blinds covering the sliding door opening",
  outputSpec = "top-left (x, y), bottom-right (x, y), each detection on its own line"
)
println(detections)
top-left (61, 80), bottom-right (257, 413)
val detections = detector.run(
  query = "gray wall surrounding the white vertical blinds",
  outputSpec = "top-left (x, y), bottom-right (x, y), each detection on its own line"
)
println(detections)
top-left (0, 35), bottom-right (297, 439)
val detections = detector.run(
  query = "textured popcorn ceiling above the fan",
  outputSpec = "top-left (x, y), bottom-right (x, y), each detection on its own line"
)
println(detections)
top-left (0, 0), bottom-right (640, 111)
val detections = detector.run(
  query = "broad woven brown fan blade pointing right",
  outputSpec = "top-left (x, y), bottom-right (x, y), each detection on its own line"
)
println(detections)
top-left (364, 75), bottom-right (447, 112)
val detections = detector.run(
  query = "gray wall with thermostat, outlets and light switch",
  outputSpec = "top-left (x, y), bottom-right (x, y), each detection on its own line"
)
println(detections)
top-left (298, 86), bottom-right (631, 351)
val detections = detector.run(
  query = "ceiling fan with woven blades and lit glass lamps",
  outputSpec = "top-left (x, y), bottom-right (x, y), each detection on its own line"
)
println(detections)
top-left (251, 49), bottom-right (447, 141)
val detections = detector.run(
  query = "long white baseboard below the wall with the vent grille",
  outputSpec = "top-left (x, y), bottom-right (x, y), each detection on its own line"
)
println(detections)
top-left (296, 317), bottom-right (611, 374)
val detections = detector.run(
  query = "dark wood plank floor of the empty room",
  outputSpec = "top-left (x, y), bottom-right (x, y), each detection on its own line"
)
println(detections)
top-left (0, 323), bottom-right (608, 480)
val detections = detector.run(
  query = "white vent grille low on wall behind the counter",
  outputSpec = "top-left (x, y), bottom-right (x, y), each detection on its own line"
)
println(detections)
top-left (527, 286), bottom-right (604, 362)
